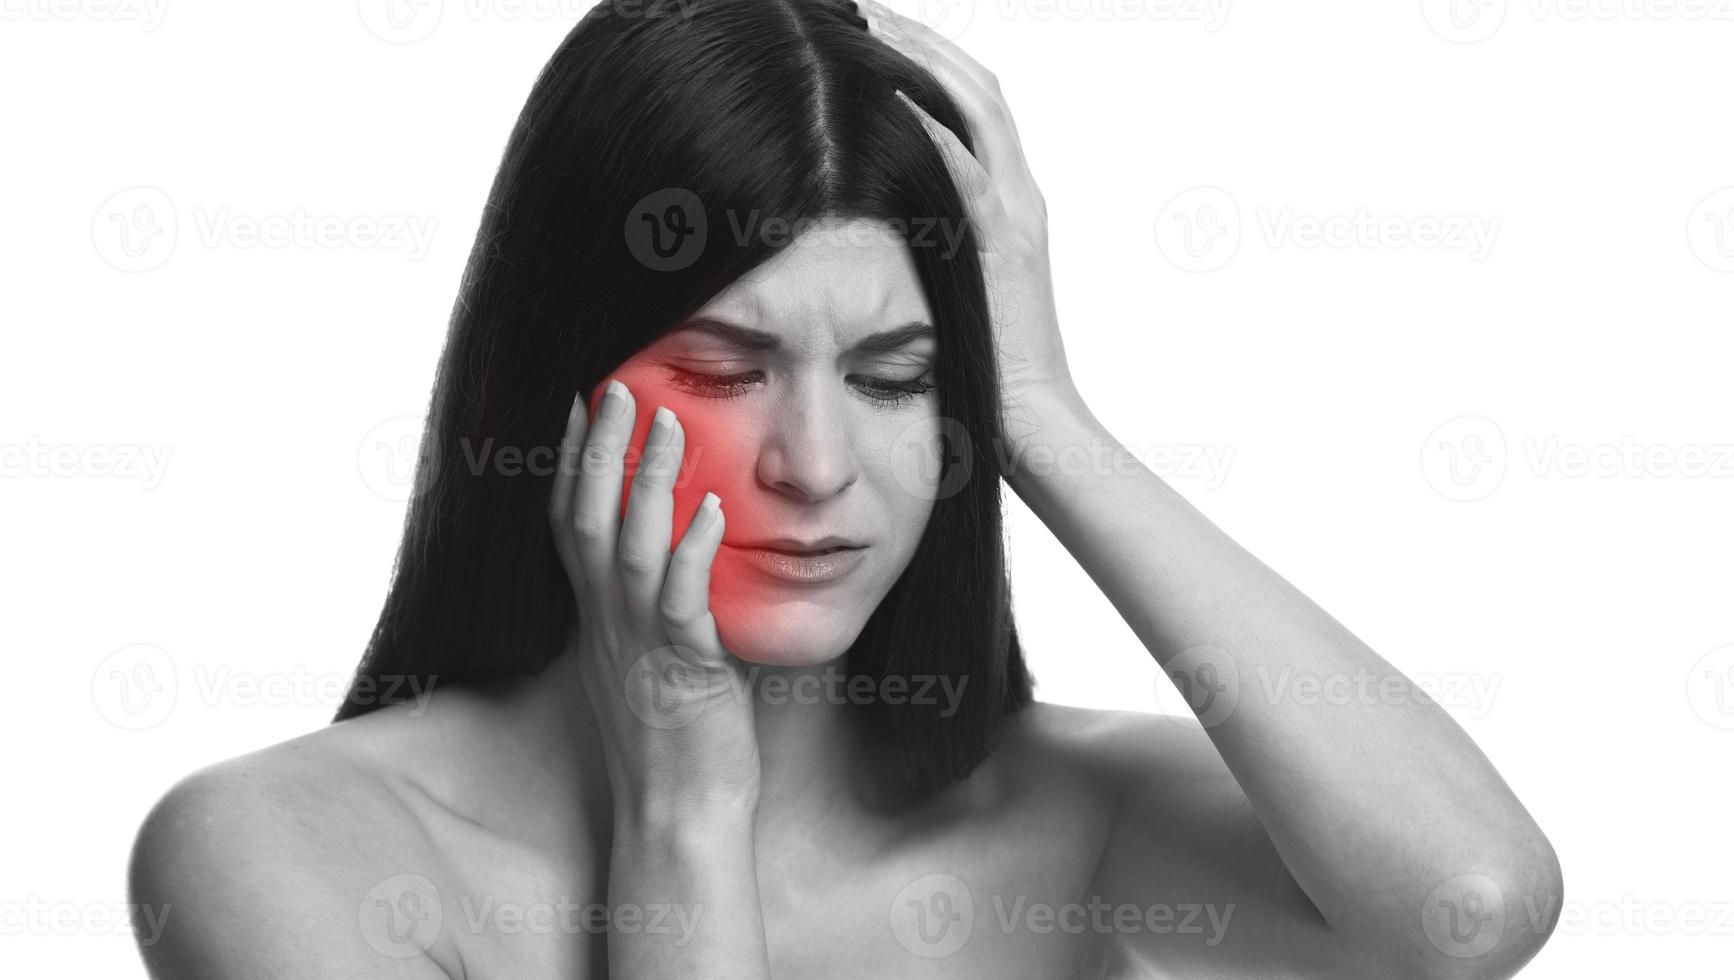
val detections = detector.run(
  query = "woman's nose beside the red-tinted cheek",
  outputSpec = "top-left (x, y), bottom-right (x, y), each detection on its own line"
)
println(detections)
top-left (758, 376), bottom-right (860, 503)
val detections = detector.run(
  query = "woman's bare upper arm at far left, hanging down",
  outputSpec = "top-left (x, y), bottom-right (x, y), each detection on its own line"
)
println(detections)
top-left (128, 763), bottom-right (449, 980)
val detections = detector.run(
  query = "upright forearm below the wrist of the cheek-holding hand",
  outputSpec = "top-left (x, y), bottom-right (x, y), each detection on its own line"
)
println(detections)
top-left (609, 807), bottom-right (770, 980)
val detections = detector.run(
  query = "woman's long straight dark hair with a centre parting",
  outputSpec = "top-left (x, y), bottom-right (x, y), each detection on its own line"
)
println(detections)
top-left (335, 0), bottom-right (1032, 789)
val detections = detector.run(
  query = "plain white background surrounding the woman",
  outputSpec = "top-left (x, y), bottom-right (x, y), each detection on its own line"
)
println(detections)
top-left (0, 0), bottom-right (1734, 978)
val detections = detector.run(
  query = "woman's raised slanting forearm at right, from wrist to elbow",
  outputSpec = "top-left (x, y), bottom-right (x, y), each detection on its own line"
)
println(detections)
top-left (1007, 392), bottom-right (1557, 940)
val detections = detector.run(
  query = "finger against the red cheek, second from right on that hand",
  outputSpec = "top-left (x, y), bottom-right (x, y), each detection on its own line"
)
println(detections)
top-left (616, 408), bottom-right (687, 623)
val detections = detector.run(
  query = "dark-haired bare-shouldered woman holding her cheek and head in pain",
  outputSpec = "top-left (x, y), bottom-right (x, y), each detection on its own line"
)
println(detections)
top-left (132, 0), bottom-right (1561, 978)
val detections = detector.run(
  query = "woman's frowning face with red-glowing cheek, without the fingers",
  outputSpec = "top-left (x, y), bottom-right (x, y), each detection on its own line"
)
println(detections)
top-left (591, 219), bottom-right (940, 664)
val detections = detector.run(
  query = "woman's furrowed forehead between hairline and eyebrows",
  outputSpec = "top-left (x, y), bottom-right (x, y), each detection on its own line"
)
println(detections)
top-left (699, 219), bottom-right (933, 347)
